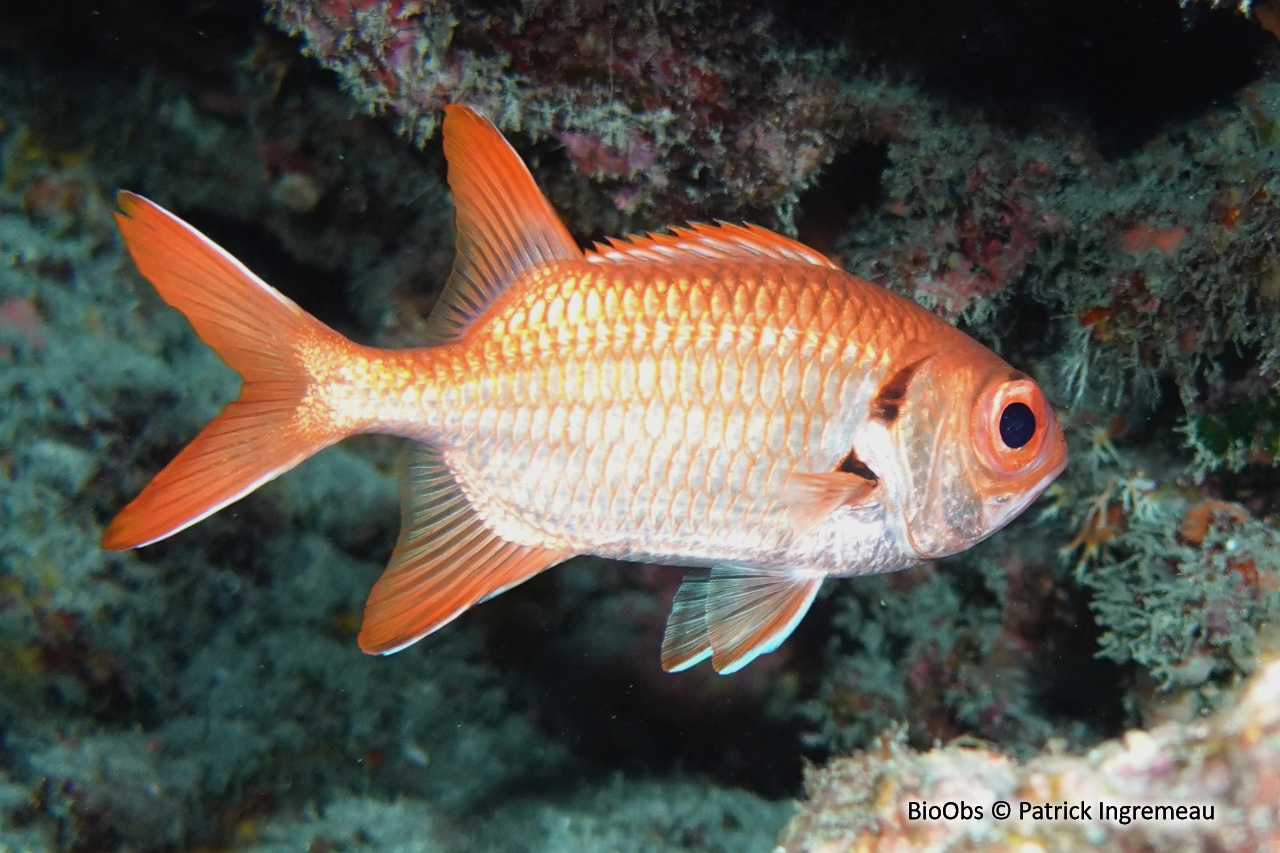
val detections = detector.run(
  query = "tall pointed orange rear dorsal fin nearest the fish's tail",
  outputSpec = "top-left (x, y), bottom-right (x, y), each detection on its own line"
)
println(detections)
top-left (426, 104), bottom-right (582, 343)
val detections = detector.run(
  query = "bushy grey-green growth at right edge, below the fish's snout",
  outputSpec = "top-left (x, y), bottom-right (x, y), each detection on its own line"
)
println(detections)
top-left (1065, 458), bottom-right (1280, 690)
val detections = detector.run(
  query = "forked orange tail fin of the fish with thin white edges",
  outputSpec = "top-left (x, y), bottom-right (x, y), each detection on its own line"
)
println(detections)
top-left (102, 192), bottom-right (353, 551)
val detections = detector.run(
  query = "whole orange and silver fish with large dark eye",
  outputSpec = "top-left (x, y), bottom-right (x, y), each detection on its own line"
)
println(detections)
top-left (102, 105), bottom-right (1068, 674)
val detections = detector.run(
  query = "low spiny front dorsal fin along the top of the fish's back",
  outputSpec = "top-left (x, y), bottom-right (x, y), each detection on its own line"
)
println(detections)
top-left (586, 222), bottom-right (840, 269)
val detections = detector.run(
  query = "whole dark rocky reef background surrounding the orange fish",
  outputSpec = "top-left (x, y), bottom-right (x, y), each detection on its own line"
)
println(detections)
top-left (0, 0), bottom-right (1280, 853)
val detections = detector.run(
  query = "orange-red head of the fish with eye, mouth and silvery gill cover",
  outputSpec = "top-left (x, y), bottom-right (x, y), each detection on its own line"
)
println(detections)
top-left (873, 350), bottom-right (1066, 558)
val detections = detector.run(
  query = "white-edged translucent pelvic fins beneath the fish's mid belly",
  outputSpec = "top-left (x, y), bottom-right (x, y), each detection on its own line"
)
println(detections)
top-left (662, 566), bottom-right (822, 675)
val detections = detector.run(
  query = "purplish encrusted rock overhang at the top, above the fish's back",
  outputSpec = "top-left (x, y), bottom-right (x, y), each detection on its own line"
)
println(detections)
top-left (268, 0), bottom-right (850, 224)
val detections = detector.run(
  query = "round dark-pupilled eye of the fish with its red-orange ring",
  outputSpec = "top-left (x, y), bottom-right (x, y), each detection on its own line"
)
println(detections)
top-left (973, 373), bottom-right (1053, 476)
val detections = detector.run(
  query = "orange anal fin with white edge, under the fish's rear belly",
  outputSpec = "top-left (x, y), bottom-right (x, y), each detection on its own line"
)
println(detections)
top-left (360, 446), bottom-right (573, 654)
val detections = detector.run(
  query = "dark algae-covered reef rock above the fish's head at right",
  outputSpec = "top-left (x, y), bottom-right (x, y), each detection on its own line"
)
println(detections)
top-left (837, 57), bottom-right (1280, 412)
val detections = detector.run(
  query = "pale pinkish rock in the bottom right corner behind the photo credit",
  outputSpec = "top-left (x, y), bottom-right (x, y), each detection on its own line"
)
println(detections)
top-left (778, 650), bottom-right (1280, 853)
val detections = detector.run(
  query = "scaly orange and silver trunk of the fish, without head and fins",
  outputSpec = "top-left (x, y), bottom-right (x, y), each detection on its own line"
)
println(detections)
top-left (381, 253), bottom-right (1011, 575)
